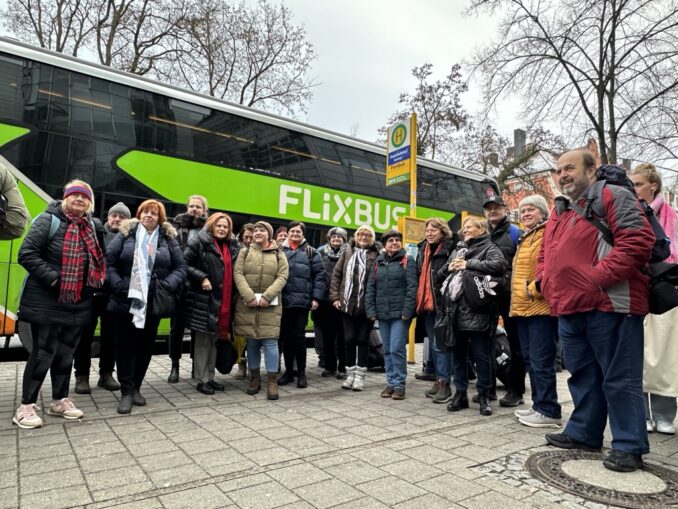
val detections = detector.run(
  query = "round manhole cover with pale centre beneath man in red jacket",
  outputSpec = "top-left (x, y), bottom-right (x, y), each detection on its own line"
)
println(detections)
top-left (525, 450), bottom-right (678, 509)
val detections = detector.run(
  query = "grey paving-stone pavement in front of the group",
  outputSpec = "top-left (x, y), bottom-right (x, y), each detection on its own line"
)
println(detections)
top-left (0, 345), bottom-right (678, 509)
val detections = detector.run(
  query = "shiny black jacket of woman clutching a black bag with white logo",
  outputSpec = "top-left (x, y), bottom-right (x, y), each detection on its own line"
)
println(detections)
top-left (440, 235), bottom-right (509, 333)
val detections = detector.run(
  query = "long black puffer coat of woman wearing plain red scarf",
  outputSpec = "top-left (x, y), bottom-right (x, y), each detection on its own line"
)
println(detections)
top-left (184, 230), bottom-right (240, 334)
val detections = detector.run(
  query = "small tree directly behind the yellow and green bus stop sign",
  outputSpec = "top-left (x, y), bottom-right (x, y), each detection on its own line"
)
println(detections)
top-left (378, 63), bottom-right (467, 159)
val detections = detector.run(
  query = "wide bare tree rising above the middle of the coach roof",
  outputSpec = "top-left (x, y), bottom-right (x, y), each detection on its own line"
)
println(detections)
top-left (161, 0), bottom-right (316, 114)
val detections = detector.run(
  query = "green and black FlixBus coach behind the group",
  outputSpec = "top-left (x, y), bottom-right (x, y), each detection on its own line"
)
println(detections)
top-left (0, 37), bottom-right (498, 354)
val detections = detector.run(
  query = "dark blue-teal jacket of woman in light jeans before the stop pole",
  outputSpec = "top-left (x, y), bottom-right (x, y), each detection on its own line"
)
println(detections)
top-left (365, 249), bottom-right (418, 320)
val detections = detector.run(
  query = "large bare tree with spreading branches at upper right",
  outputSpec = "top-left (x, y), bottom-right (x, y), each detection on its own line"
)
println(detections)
top-left (470, 0), bottom-right (678, 163)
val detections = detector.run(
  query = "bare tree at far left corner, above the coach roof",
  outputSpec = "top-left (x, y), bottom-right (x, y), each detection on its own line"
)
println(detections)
top-left (1, 0), bottom-right (93, 56)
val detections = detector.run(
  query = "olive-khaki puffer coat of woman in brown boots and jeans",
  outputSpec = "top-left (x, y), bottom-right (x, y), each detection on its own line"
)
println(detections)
top-left (233, 242), bottom-right (289, 339)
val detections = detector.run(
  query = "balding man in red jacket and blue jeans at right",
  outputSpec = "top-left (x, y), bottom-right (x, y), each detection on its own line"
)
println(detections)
top-left (535, 150), bottom-right (654, 472)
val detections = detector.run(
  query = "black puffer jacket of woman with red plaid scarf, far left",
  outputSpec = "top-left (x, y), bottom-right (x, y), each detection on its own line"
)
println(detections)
top-left (18, 200), bottom-right (99, 326)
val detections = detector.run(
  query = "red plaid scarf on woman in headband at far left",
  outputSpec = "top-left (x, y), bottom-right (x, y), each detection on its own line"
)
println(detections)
top-left (58, 213), bottom-right (106, 303)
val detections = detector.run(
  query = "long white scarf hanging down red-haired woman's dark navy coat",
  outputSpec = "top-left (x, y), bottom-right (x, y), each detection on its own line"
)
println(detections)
top-left (127, 225), bottom-right (160, 329)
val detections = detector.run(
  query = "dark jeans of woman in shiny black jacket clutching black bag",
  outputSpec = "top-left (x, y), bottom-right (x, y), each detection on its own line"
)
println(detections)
top-left (452, 332), bottom-right (494, 393)
